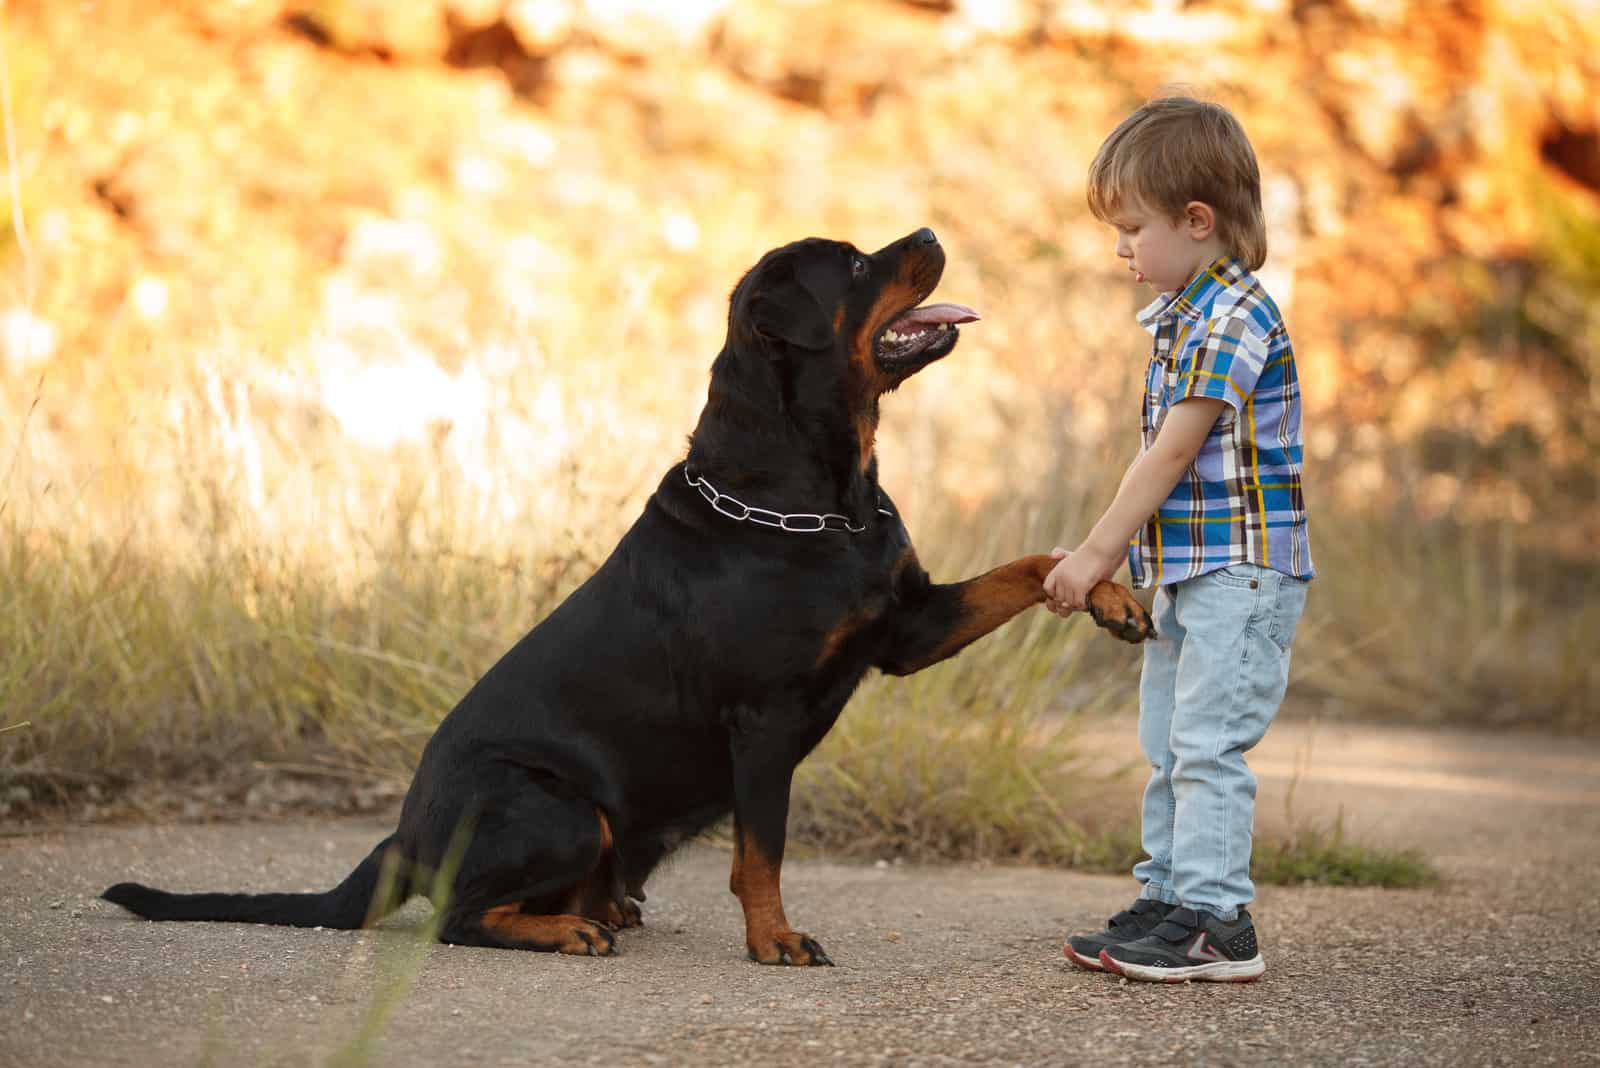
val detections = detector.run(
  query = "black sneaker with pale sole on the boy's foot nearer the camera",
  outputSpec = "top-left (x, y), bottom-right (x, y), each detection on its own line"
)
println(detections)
top-left (1101, 908), bottom-right (1267, 983)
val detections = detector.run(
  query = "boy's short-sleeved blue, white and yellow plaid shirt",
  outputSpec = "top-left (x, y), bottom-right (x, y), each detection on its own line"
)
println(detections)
top-left (1128, 256), bottom-right (1312, 587)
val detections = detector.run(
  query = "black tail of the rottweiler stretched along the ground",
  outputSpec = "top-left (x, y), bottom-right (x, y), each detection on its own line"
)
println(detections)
top-left (101, 835), bottom-right (408, 931)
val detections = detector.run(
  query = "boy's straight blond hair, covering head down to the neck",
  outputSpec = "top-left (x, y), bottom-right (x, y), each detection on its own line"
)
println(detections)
top-left (1088, 96), bottom-right (1267, 270)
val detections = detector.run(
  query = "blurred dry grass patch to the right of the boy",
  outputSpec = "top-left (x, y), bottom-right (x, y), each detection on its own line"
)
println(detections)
top-left (1294, 508), bottom-right (1600, 732)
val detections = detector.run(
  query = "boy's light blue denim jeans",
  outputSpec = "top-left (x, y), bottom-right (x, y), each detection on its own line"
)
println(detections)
top-left (1133, 563), bottom-right (1306, 919)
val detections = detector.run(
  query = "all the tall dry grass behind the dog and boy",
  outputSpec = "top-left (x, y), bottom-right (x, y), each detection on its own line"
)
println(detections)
top-left (0, 369), bottom-right (1600, 831)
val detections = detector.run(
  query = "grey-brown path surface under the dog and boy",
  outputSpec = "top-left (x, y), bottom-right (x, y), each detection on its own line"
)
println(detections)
top-left (0, 723), bottom-right (1600, 1068)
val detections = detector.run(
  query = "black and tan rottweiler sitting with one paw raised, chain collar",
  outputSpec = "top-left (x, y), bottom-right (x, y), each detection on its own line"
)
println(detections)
top-left (104, 229), bottom-right (1154, 964)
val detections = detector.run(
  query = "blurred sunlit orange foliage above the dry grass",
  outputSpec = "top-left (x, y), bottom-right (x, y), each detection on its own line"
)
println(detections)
top-left (0, 0), bottom-right (1600, 553)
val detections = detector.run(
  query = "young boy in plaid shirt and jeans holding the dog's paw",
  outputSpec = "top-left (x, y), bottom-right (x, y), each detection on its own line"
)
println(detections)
top-left (1045, 96), bottom-right (1312, 982)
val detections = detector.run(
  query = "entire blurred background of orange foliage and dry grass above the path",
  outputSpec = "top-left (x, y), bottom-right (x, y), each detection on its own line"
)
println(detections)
top-left (0, 0), bottom-right (1600, 860)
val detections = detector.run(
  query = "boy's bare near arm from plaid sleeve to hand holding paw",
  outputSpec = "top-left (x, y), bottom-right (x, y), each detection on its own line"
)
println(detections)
top-left (1045, 397), bottom-right (1226, 609)
